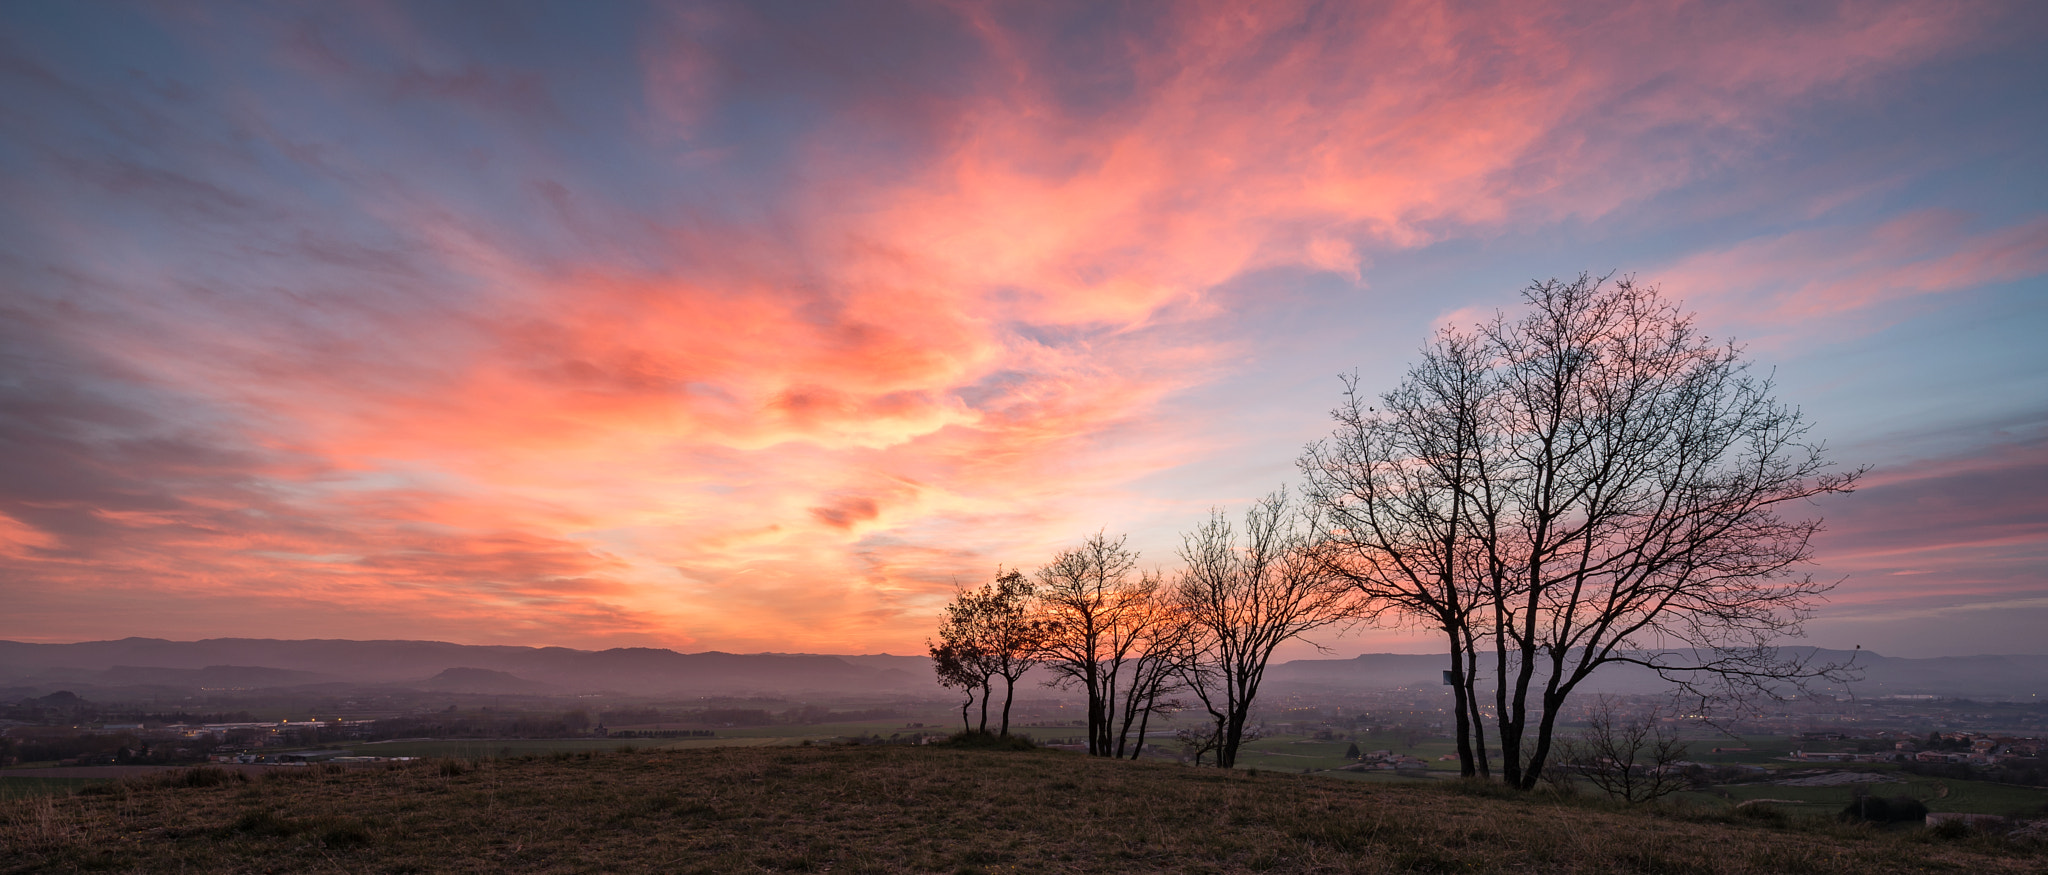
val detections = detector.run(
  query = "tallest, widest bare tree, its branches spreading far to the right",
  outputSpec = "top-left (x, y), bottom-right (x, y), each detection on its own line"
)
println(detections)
top-left (1479, 275), bottom-right (1864, 787)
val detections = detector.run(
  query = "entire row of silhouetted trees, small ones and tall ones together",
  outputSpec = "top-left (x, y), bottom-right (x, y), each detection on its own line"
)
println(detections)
top-left (932, 275), bottom-right (1862, 789)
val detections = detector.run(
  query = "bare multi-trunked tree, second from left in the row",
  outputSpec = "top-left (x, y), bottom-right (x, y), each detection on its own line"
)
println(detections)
top-left (1038, 533), bottom-right (1178, 756)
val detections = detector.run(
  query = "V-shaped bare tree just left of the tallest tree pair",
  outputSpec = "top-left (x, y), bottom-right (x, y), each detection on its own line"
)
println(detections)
top-left (1178, 490), bottom-right (1354, 768)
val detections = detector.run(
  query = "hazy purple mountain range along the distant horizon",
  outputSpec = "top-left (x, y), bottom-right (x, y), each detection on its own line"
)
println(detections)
top-left (0, 637), bottom-right (2048, 699)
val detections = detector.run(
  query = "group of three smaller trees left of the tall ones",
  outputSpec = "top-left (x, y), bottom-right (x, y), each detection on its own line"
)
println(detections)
top-left (930, 492), bottom-right (1356, 766)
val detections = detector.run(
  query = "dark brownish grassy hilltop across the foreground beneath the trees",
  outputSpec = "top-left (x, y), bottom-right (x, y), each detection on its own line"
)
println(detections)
top-left (0, 746), bottom-right (2048, 875)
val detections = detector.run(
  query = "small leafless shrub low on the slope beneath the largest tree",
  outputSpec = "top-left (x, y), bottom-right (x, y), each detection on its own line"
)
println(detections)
top-left (1546, 697), bottom-right (1692, 805)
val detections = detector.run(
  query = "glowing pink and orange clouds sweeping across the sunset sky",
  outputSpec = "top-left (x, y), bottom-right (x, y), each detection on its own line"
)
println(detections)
top-left (0, 2), bottom-right (2015, 652)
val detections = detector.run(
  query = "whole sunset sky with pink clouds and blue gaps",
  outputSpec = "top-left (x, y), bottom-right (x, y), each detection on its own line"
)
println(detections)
top-left (0, 0), bottom-right (2048, 656)
